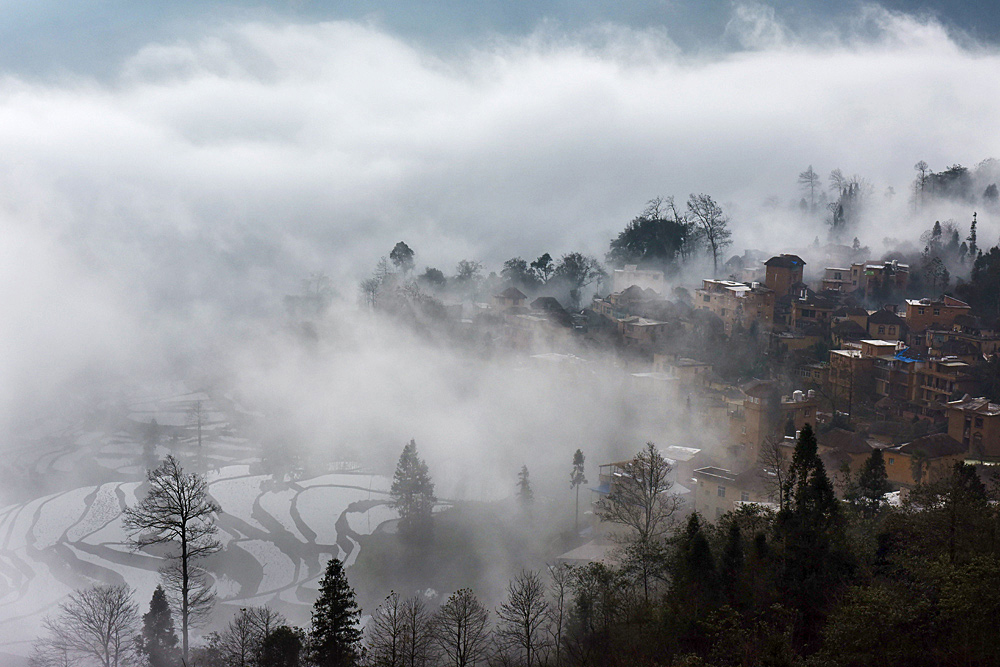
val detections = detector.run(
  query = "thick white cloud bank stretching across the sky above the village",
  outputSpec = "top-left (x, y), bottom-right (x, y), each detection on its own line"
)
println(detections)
top-left (0, 5), bottom-right (1000, 470)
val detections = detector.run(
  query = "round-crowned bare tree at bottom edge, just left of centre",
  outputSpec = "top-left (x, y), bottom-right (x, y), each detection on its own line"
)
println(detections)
top-left (434, 588), bottom-right (490, 667)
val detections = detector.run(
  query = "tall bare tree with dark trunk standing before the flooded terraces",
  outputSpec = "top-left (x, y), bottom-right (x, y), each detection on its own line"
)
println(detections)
top-left (124, 456), bottom-right (221, 663)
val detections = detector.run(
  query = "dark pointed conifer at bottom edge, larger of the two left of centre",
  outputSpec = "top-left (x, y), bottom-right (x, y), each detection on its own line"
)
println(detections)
top-left (309, 558), bottom-right (361, 667)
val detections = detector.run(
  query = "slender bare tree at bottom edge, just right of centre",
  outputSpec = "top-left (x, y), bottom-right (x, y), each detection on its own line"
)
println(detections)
top-left (496, 570), bottom-right (549, 667)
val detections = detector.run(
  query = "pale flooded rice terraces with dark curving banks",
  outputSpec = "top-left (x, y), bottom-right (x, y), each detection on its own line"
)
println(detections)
top-left (0, 388), bottom-right (397, 662)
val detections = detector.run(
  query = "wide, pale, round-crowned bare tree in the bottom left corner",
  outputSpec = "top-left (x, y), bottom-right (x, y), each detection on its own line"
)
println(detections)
top-left (32, 584), bottom-right (139, 667)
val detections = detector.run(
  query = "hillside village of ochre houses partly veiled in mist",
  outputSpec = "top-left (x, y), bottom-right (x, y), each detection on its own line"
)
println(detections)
top-left (364, 235), bottom-right (1000, 536)
